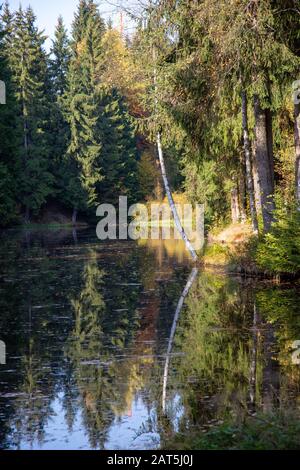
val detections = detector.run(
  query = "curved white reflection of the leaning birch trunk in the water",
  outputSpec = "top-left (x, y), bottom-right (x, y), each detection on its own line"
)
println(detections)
top-left (162, 268), bottom-right (198, 414)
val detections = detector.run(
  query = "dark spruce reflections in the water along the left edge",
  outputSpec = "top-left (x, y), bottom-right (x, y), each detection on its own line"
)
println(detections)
top-left (0, 234), bottom-right (86, 448)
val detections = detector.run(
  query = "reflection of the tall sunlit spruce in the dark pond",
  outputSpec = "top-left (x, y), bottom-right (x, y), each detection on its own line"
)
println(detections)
top-left (66, 255), bottom-right (144, 448)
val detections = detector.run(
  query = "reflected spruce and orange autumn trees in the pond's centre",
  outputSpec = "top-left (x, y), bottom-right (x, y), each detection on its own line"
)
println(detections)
top-left (64, 244), bottom-right (191, 448)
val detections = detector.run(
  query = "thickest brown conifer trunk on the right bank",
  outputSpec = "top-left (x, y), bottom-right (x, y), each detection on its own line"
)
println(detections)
top-left (254, 95), bottom-right (275, 232)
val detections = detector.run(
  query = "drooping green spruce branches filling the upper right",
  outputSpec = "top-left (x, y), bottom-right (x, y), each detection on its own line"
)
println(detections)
top-left (140, 0), bottom-right (299, 234)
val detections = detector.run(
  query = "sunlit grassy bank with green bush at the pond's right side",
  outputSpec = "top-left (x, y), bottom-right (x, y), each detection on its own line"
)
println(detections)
top-left (202, 210), bottom-right (300, 279)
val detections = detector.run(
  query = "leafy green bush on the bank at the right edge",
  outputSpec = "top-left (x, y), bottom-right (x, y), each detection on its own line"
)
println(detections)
top-left (256, 208), bottom-right (300, 274)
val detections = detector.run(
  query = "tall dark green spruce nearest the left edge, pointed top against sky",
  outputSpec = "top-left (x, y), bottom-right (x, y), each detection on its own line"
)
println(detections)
top-left (10, 7), bottom-right (53, 222)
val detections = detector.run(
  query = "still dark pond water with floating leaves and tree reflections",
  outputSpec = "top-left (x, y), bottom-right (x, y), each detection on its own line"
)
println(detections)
top-left (0, 230), bottom-right (300, 450)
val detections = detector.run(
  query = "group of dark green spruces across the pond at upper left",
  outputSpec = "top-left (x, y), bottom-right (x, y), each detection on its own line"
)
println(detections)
top-left (0, 0), bottom-right (138, 226)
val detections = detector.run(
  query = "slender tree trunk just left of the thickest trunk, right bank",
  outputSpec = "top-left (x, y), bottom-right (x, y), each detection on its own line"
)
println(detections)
top-left (242, 91), bottom-right (258, 234)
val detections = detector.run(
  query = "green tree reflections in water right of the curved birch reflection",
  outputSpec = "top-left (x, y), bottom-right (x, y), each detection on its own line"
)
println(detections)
top-left (161, 273), bottom-right (300, 446)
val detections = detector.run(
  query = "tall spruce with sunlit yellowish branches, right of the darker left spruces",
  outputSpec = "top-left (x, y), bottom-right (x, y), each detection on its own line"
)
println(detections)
top-left (65, 0), bottom-right (104, 223)
